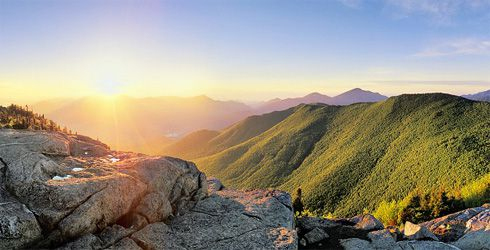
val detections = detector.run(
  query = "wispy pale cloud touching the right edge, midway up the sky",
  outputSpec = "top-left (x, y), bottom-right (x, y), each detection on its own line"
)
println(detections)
top-left (415, 38), bottom-right (490, 57)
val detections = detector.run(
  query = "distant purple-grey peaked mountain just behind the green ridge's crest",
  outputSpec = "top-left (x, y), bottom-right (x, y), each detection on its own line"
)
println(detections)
top-left (256, 88), bottom-right (388, 114)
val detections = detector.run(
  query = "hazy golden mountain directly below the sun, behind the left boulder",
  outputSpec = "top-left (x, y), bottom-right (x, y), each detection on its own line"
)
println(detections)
top-left (33, 96), bottom-right (251, 154)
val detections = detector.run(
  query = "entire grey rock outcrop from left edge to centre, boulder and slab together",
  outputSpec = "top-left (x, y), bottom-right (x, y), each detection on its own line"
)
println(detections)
top-left (0, 130), bottom-right (297, 249)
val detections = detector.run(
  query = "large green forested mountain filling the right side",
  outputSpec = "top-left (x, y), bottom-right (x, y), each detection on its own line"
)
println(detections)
top-left (195, 94), bottom-right (490, 216)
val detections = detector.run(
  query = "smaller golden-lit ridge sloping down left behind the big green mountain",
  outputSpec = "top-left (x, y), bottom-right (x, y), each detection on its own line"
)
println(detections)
top-left (161, 108), bottom-right (295, 159)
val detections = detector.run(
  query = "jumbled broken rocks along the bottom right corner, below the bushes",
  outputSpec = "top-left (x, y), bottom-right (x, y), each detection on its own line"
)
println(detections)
top-left (297, 205), bottom-right (490, 250)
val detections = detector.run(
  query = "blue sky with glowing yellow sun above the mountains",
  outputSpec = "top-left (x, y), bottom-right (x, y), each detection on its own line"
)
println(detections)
top-left (0, 0), bottom-right (490, 104)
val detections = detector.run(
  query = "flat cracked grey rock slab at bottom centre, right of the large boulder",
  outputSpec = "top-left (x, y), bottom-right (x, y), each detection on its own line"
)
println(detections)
top-left (130, 189), bottom-right (297, 249)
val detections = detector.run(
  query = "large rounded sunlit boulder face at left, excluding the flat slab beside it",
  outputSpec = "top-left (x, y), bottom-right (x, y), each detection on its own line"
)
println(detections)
top-left (0, 130), bottom-right (207, 249)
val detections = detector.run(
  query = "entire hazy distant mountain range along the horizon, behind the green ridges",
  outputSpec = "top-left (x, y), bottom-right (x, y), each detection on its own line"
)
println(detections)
top-left (31, 88), bottom-right (490, 154)
